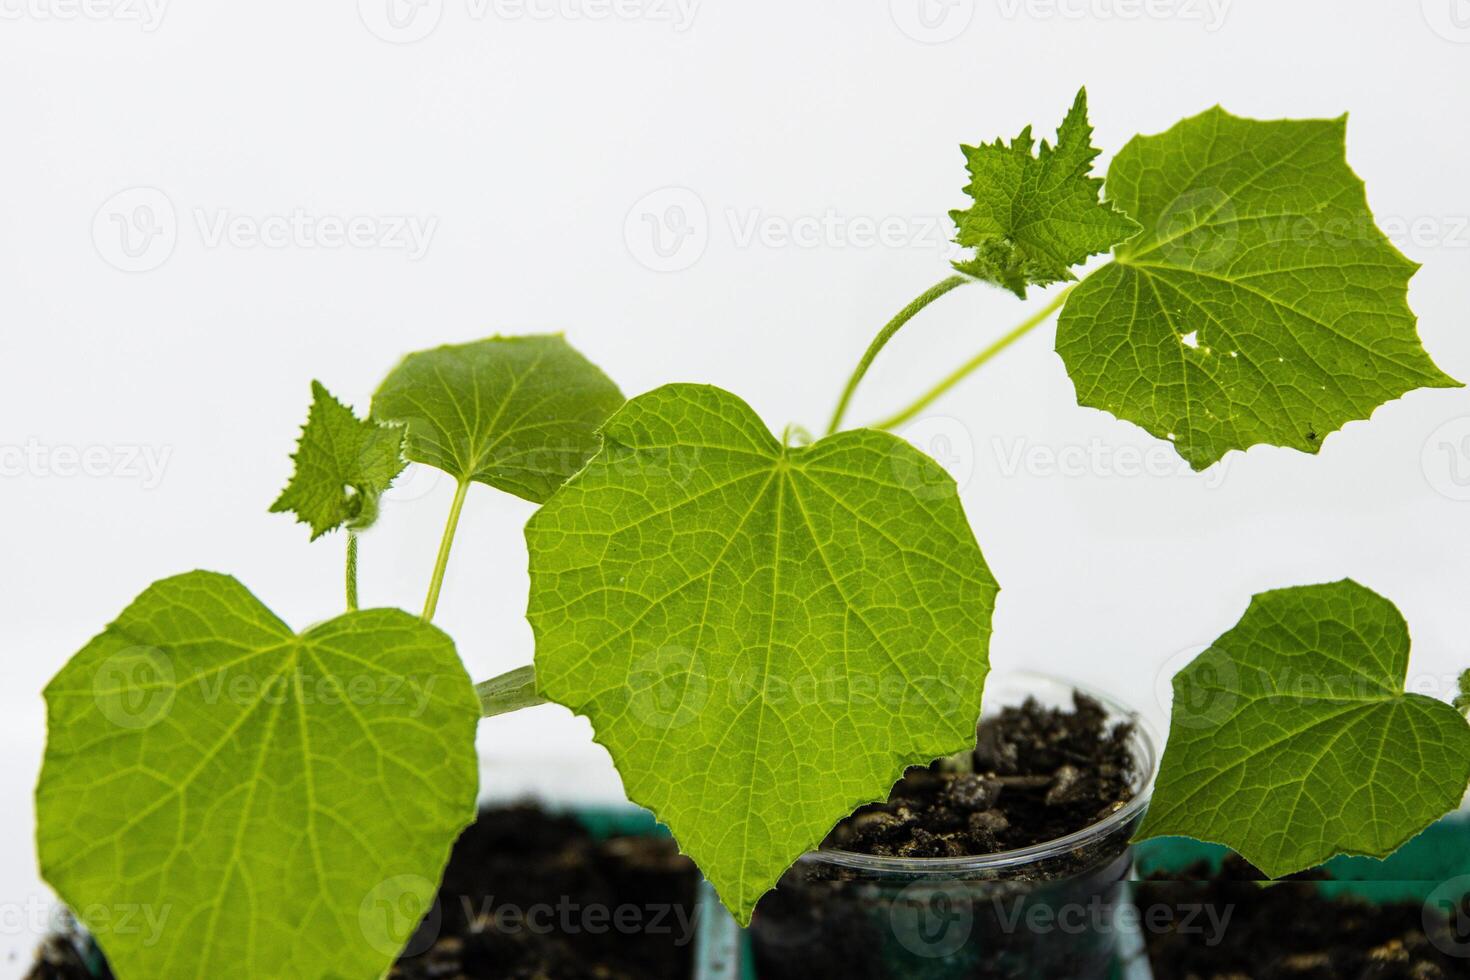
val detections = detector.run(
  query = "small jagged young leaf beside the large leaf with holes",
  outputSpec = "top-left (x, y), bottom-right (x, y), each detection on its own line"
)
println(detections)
top-left (950, 88), bottom-right (1138, 298)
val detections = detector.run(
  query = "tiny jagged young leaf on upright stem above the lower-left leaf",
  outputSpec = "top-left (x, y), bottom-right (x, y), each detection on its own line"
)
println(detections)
top-left (270, 381), bottom-right (404, 541)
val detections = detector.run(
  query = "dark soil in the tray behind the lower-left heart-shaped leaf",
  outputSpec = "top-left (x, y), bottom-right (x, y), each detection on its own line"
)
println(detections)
top-left (26, 805), bottom-right (698, 980)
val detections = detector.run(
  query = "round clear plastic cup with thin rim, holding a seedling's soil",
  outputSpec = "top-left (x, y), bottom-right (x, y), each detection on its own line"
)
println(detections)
top-left (750, 673), bottom-right (1155, 980)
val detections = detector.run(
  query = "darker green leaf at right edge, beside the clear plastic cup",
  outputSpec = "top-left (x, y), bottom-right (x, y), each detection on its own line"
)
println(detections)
top-left (1139, 580), bottom-right (1470, 877)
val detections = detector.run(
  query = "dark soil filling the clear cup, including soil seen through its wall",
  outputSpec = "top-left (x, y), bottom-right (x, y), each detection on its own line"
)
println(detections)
top-left (751, 695), bottom-right (1138, 980)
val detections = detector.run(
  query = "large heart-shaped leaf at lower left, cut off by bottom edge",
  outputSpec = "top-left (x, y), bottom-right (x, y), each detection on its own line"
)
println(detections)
top-left (37, 572), bottom-right (479, 980)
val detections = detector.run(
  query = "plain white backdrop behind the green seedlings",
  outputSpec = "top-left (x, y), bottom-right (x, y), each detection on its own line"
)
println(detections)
top-left (0, 0), bottom-right (1470, 976)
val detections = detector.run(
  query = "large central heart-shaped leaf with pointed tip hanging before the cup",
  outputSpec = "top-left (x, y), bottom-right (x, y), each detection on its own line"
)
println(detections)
top-left (526, 385), bottom-right (997, 920)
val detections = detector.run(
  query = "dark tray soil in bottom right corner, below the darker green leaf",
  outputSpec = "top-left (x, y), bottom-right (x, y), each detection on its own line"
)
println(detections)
top-left (1135, 855), bottom-right (1470, 980)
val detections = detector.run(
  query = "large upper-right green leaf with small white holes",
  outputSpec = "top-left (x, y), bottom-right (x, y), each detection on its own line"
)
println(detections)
top-left (1057, 109), bottom-right (1458, 469)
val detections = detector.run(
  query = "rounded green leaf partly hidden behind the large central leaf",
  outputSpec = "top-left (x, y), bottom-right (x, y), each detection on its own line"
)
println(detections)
top-left (372, 335), bottom-right (623, 504)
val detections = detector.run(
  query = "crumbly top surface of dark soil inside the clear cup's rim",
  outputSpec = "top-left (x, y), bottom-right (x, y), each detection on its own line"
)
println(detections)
top-left (823, 693), bottom-right (1133, 858)
